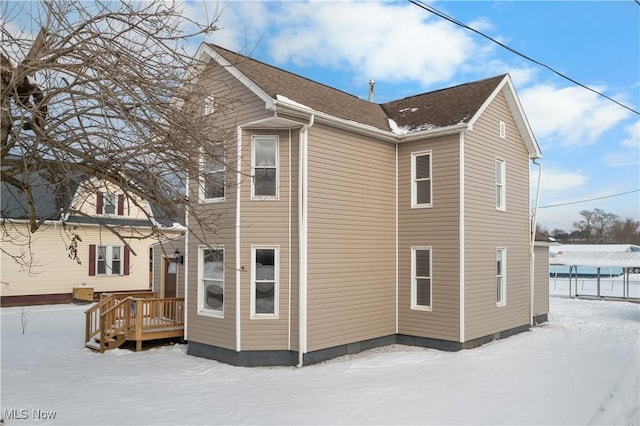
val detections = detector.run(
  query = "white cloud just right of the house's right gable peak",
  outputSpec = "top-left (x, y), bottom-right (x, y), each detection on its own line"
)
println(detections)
top-left (520, 84), bottom-right (628, 147)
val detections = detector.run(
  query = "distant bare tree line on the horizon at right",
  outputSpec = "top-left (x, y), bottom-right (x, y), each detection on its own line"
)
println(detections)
top-left (538, 209), bottom-right (640, 245)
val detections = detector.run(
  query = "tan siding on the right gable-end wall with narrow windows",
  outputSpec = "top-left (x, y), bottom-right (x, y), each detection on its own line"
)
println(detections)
top-left (464, 93), bottom-right (530, 340)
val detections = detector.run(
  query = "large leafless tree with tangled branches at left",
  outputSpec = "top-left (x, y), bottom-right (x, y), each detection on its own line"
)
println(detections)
top-left (0, 1), bottom-right (233, 263)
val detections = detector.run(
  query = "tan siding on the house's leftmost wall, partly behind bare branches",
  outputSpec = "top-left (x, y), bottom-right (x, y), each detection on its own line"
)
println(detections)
top-left (185, 64), bottom-right (270, 350)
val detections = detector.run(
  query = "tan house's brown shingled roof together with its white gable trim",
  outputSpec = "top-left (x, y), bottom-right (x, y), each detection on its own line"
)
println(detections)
top-left (198, 43), bottom-right (540, 158)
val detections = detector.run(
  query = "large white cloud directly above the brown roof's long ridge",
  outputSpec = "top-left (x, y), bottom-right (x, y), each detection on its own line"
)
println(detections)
top-left (213, 2), bottom-right (484, 86)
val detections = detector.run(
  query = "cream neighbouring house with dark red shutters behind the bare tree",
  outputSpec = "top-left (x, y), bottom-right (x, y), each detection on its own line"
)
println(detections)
top-left (0, 172), bottom-right (185, 306)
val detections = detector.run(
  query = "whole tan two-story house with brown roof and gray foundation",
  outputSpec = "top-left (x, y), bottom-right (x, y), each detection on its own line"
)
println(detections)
top-left (185, 44), bottom-right (548, 365)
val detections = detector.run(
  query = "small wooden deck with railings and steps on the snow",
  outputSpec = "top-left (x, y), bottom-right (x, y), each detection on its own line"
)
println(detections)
top-left (85, 292), bottom-right (184, 353)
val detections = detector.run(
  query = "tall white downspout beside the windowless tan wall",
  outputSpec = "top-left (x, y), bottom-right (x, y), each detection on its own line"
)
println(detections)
top-left (296, 115), bottom-right (315, 368)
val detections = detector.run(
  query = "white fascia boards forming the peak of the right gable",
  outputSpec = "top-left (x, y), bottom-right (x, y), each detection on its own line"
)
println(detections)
top-left (469, 74), bottom-right (542, 159)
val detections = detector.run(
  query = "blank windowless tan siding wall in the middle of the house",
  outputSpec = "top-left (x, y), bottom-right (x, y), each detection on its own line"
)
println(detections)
top-left (307, 124), bottom-right (395, 351)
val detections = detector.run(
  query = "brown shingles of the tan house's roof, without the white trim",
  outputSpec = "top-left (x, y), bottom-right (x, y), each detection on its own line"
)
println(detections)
top-left (208, 44), bottom-right (505, 131)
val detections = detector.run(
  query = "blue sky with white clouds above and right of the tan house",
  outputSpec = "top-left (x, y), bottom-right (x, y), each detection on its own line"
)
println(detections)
top-left (187, 0), bottom-right (640, 231)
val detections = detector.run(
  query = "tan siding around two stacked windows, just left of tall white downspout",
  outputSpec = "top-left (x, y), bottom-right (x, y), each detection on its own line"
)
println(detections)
top-left (240, 129), bottom-right (298, 350)
